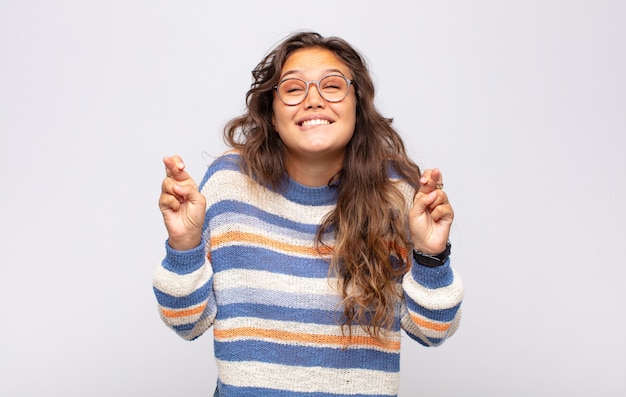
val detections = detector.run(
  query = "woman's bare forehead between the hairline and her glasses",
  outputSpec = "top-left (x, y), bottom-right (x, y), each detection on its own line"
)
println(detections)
top-left (281, 47), bottom-right (352, 78)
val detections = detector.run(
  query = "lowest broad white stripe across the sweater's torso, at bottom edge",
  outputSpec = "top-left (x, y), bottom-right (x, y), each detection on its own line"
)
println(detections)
top-left (217, 360), bottom-right (399, 395)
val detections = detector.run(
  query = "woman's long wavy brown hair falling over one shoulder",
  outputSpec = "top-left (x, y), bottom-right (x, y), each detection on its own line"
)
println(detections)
top-left (224, 32), bottom-right (420, 339)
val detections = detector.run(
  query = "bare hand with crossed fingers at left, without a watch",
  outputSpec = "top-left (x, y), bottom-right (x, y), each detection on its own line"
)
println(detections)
top-left (159, 156), bottom-right (206, 251)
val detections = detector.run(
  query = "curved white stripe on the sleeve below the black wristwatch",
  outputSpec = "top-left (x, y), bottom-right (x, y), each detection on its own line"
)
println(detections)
top-left (403, 269), bottom-right (463, 310)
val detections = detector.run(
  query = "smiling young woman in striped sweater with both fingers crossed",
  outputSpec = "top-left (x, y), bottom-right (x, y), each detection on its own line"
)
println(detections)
top-left (154, 32), bottom-right (463, 397)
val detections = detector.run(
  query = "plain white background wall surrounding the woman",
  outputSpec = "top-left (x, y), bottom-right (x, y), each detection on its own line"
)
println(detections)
top-left (0, 0), bottom-right (626, 397)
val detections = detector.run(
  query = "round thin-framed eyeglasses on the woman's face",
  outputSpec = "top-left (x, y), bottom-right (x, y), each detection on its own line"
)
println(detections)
top-left (274, 74), bottom-right (354, 106)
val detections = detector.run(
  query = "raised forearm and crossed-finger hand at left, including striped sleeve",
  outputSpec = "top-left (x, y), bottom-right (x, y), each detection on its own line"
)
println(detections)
top-left (154, 156), bottom-right (217, 340)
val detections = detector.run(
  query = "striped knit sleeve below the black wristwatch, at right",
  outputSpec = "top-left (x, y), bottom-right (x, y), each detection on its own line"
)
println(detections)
top-left (401, 258), bottom-right (463, 346)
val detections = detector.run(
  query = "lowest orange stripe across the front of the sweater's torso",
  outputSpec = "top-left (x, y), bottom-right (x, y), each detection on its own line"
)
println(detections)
top-left (214, 327), bottom-right (400, 350)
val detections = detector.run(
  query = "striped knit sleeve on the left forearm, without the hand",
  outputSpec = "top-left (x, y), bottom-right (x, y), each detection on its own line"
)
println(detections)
top-left (153, 238), bottom-right (217, 340)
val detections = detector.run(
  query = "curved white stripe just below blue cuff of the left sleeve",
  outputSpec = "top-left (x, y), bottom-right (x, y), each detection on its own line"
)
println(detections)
top-left (154, 260), bottom-right (213, 298)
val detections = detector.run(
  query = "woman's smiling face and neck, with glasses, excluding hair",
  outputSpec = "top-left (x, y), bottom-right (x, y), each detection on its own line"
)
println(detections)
top-left (272, 47), bottom-right (357, 181)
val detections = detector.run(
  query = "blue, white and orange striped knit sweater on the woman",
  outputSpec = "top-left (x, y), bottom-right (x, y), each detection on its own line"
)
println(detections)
top-left (154, 152), bottom-right (463, 397)
